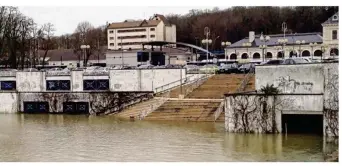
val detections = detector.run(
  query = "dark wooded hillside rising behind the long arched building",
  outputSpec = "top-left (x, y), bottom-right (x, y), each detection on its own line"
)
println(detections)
top-left (166, 6), bottom-right (338, 50)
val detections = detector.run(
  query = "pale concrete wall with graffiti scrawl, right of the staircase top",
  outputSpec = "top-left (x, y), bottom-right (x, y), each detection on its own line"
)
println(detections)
top-left (255, 64), bottom-right (324, 93)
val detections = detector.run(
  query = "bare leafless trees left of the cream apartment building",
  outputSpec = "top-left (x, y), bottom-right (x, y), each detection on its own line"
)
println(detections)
top-left (0, 6), bottom-right (107, 69)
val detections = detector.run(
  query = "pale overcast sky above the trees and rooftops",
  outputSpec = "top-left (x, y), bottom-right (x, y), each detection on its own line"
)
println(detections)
top-left (19, 6), bottom-right (228, 35)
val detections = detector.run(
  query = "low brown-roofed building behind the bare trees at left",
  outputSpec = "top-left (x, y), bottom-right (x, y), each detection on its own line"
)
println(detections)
top-left (39, 49), bottom-right (106, 67)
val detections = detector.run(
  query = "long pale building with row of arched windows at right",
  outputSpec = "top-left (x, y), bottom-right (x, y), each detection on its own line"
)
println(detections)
top-left (225, 13), bottom-right (338, 62)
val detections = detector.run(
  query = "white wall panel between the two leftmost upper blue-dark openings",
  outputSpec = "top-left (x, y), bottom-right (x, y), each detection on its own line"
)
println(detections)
top-left (16, 72), bottom-right (46, 92)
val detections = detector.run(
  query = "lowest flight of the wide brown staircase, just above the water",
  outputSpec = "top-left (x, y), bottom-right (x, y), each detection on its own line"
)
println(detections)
top-left (145, 99), bottom-right (221, 121)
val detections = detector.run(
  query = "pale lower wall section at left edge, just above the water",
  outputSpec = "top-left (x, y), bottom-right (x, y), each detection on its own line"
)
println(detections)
top-left (0, 92), bottom-right (18, 113)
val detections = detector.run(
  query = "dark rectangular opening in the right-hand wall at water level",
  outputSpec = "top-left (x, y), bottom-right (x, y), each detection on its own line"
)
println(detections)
top-left (281, 114), bottom-right (323, 135)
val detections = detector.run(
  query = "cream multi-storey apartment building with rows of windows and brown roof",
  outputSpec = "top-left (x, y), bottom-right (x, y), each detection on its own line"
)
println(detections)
top-left (107, 14), bottom-right (176, 50)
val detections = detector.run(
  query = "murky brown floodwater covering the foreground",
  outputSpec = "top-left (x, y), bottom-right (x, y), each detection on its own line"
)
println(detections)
top-left (0, 114), bottom-right (336, 162)
